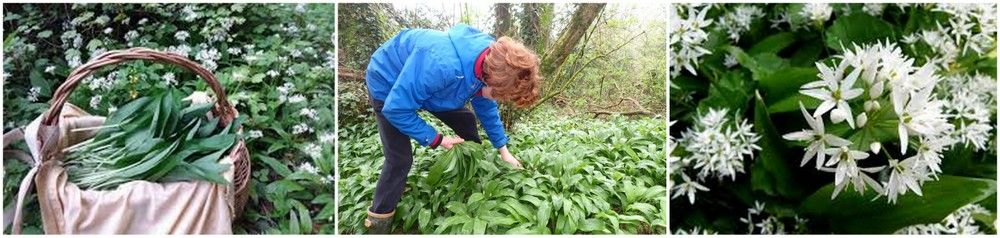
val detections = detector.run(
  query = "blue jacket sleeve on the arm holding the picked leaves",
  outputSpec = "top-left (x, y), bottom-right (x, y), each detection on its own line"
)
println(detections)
top-left (382, 52), bottom-right (444, 146)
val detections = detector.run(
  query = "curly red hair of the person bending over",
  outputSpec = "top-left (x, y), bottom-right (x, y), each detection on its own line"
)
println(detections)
top-left (483, 36), bottom-right (542, 108)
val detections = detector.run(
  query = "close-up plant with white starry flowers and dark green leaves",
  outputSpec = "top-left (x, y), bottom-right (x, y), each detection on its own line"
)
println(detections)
top-left (668, 3), bottom-right (997, 234)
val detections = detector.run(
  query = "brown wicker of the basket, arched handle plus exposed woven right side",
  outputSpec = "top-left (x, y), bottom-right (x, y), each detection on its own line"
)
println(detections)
top-left (41, 48), bottom-right (250, 217)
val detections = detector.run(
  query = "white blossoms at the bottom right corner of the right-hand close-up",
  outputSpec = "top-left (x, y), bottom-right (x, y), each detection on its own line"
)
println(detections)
top-left (895, 203), bottom-right (992, 235)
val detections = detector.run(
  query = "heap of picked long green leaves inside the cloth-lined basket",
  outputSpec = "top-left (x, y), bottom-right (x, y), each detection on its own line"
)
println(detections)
top-left (64, 90), bottom-right (242, 189)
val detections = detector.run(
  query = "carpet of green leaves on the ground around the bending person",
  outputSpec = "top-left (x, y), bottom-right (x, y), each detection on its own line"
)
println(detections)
top-left (338, 116), bottom-right (667, 234)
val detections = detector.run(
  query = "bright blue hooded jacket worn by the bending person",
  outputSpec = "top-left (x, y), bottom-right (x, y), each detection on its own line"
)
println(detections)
top-left (365, 24), bottom-right (507, 148)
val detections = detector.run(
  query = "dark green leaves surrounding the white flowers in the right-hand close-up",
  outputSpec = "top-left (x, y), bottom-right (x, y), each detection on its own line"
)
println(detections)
top-left (669, 4), bottom-right (997, 233)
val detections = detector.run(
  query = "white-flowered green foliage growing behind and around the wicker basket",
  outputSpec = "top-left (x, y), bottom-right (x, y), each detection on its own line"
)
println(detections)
top-left (3, 4), bottom-right (335, 233)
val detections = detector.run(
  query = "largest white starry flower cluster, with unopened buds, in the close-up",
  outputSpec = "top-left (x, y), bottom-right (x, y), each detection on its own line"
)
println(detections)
top-left (784, 40), bottom-right (988, 203)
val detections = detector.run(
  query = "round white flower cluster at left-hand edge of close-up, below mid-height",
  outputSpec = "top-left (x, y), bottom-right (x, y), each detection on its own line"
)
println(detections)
top-left (667, 109), bottom-right (760, 204)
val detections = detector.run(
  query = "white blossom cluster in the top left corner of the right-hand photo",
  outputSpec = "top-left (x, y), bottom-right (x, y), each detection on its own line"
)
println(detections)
top-left (667, 4), bottom-right (712, 77)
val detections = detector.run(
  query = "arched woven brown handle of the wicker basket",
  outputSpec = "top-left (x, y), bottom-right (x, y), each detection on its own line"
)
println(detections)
top-left (41, 47), bottom-right (236, 126)
